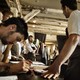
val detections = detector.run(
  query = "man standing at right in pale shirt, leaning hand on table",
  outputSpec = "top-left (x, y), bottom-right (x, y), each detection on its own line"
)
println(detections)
top-left (43, 0), bottom-right (80, 80)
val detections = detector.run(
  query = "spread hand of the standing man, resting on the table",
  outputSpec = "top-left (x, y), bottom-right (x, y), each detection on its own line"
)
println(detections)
top-left (42, 61), bottom-right (61, 79)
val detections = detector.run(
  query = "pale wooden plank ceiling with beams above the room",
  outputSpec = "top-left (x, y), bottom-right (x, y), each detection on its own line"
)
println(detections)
top-left (3, 0), bottom-right (80, 41)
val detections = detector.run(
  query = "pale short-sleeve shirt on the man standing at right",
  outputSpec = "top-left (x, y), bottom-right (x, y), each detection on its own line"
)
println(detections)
top-left (68, 10), bottom-right (80, 35)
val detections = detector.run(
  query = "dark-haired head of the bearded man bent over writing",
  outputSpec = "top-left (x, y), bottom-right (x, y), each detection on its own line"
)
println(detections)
top-left (0, 17), bottom-right (28, 44)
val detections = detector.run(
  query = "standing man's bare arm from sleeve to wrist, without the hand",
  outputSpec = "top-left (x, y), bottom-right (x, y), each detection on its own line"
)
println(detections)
top-left (58, 34), bottom-right (80, 65)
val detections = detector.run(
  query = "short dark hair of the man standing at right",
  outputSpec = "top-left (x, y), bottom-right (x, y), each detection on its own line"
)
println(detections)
top-left (61, 0), bottom-right (77, 10)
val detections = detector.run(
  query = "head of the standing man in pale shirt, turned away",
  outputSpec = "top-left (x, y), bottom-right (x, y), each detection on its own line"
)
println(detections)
top-left (61, 0), bottom-right (77, 18)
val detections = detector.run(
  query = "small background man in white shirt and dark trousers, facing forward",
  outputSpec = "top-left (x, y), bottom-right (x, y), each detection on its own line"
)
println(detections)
top-left (24, 35), bottom-right (37, 61)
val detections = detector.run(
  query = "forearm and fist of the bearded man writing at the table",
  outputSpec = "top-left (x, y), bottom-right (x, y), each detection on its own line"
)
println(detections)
top-left (0, 61), bottom-right (31, 75)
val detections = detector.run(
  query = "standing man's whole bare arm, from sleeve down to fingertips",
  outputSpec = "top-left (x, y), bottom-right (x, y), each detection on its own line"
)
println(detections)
top-left (43, 34), bottom-right (80, 78)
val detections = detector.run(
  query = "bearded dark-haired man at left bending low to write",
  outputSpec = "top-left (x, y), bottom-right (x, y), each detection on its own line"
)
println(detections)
top-left (0, 17), bottom-right (30, 75)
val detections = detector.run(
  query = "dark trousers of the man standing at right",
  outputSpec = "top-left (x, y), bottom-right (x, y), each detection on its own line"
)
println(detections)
top-left (64, 46), bottom-right (80, 80)
